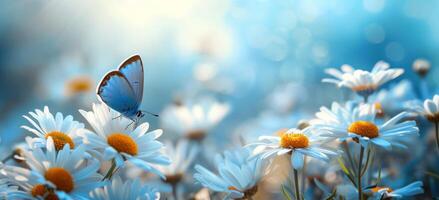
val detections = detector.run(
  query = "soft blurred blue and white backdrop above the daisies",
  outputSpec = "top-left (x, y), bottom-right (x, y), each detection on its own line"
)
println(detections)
top-left (0, 0), bottom-right (439, 198)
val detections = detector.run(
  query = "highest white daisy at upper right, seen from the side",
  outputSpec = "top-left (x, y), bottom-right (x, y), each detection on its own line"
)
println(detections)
top-left (322, 61), bottom-right (404, 98)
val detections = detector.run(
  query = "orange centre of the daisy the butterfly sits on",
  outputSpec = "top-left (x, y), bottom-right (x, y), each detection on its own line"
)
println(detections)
top-left (107, 133), bottom-right (137, 156)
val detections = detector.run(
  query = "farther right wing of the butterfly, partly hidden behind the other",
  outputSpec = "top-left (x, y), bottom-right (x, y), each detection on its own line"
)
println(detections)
top-left (119, 55), bottom-right (143, 103)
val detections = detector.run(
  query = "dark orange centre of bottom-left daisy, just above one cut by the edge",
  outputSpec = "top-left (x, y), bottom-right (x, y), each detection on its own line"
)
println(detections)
top-left (44, 167), bottom-right (74, 193)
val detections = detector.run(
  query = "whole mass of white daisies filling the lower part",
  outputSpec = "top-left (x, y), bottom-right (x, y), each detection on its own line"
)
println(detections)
top-left (0, 60), bottom-right (439, 200)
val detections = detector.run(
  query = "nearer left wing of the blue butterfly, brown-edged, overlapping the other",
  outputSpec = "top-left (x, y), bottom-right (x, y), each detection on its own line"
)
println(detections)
top-left (97, 71), bottom-right (140, 117)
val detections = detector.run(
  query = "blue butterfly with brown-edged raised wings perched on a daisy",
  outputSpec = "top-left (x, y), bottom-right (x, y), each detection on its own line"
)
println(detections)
top-left (96, 55), bottom-right (158, 121)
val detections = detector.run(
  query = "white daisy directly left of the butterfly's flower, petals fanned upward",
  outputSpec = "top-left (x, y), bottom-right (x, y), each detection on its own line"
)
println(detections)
top-left (21, 106), bottom-right (84, 150)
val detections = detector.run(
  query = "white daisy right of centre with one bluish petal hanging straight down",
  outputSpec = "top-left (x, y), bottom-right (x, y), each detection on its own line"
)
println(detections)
top-left (247, 127), bottom-right (338, 169)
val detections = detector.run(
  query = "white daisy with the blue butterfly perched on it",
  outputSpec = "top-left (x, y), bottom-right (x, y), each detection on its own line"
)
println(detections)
top-left (79, 103), bottom-right (170, 177)
